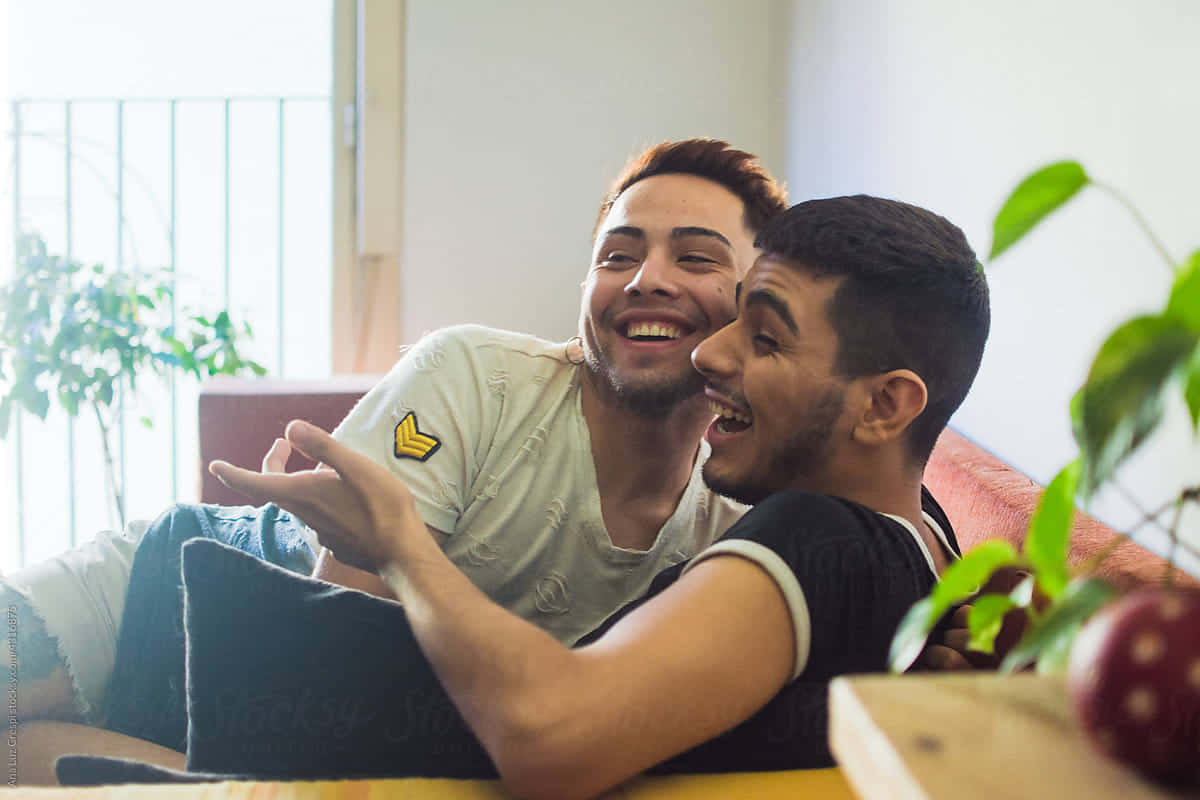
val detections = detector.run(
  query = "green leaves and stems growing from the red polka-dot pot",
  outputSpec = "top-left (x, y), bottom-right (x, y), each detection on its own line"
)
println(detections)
top-left (890, 161), bottom-right (1200, 672)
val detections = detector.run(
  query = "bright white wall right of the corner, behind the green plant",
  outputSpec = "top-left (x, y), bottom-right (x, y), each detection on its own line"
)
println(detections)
top-left (785, 0), bottom-right (1200, 563)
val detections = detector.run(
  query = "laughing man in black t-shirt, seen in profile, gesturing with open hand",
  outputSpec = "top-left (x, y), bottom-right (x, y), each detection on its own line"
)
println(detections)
top-left (190, 196), bottom-right (989, 796)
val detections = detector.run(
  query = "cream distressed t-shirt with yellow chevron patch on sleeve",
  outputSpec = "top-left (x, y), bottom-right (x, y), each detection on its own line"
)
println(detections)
top-left (334, 325), bottom-right (746, 644)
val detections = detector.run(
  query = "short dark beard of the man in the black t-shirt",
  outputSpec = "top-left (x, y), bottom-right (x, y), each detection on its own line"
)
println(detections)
top-left (702, 386), bottom-right (846, 505)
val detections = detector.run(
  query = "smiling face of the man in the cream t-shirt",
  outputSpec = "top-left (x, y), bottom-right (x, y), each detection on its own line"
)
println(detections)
top-left (580, 174), bottom-right (754, 416)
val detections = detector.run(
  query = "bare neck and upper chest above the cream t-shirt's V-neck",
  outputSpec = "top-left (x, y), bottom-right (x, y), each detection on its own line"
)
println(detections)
top-left (581, 373), bottom-right (713, 501)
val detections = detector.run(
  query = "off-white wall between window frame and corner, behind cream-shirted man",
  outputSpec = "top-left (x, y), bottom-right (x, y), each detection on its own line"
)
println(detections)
top-left (401, 0), bottom-right (786, 341)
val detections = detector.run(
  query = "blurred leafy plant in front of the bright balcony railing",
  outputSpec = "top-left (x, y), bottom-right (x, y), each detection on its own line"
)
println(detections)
top-left (0, 234), bottom-right (265, 527)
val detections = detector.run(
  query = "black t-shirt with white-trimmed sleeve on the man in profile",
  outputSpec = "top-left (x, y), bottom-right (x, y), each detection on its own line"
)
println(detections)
top-left (578, 488), bottom-right (959, 772)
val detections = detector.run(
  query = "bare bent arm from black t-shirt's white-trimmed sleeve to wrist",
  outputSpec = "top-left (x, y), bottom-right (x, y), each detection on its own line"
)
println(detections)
top-left (382, 534), bottom-right (796, 798)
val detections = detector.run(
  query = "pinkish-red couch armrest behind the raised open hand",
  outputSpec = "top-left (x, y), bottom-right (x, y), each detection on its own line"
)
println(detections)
top-left (199, 375), bottom-right (379, 505)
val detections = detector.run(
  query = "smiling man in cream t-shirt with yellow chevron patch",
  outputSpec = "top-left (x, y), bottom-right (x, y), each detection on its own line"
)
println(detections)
top-left (5, 139), bottom-right (786, 782)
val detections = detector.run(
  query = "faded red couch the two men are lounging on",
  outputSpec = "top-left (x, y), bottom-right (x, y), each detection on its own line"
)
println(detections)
top-left (199, 375), bottom-right (1200, 589)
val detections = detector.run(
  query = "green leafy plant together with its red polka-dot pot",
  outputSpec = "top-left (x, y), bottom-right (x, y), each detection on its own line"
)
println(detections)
top-left (890, 161), bottom-right (1200, 780)
